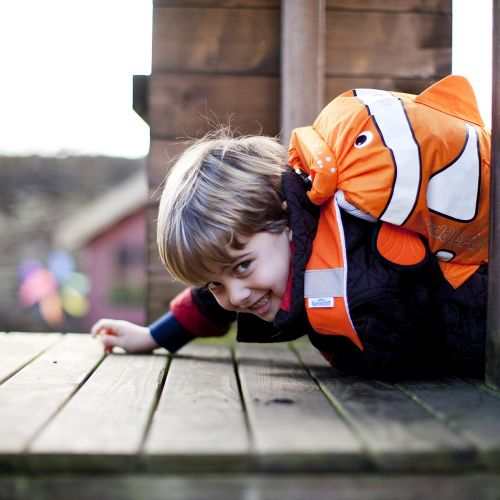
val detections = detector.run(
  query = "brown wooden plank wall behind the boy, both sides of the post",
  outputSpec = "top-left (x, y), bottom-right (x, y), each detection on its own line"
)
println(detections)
top-left (147, 0), bottom-right (451, 320)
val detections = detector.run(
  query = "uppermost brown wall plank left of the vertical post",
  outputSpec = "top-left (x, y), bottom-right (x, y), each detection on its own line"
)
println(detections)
top-left (152, 7), bottom-right (280, 75)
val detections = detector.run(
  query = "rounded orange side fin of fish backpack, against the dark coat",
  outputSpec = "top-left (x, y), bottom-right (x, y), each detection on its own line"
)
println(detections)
top-left (375, 222), bottom-right (429, 269)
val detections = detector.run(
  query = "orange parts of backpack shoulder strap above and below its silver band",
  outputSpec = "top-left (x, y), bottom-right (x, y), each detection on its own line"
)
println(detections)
top-left (305, 198), bottom-right (363, 350)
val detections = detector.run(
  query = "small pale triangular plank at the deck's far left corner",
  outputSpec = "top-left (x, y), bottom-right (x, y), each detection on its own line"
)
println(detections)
top-left (0, 333), bottom-right (61, 384)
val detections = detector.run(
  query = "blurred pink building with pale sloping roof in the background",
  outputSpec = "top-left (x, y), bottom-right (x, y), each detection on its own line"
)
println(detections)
top-left (54, 173), bottom-right (148, 330)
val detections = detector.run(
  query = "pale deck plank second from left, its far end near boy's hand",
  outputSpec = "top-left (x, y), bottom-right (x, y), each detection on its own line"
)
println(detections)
top-left (0, 334), bottom-right (102, 463)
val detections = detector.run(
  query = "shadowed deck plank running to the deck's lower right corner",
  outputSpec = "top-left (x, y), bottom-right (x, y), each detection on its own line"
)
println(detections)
top-left (397, 378), bottom-right (500, 468)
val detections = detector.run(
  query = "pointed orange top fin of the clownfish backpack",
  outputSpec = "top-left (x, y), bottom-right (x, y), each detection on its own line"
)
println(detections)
top-left (414, 75), bottom-right (484, 127)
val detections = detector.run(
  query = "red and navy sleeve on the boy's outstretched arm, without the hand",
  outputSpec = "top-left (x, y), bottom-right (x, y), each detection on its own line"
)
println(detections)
top-left (149, 287), bottom-right (236, 352)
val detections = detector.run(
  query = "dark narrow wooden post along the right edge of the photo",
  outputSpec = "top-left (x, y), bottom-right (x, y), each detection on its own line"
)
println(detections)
top-left (485, 0), bottom-right (500, 389)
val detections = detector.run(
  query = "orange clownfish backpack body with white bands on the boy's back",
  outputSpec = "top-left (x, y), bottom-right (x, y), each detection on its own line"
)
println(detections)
top-left (290, 76), bottom-right (491, 287)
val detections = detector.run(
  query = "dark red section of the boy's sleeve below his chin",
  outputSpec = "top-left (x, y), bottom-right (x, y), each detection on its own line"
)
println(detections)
top-left (170, 288), bottom-right (231, 337)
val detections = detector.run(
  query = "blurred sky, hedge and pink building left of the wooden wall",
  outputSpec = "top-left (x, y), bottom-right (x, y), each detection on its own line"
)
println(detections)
top-left (0, 0), bottom-right (152, 331)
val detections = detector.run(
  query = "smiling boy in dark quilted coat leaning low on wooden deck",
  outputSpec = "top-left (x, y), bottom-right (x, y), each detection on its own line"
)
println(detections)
top-left (91, 131), bottom-right (487, 378)
